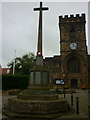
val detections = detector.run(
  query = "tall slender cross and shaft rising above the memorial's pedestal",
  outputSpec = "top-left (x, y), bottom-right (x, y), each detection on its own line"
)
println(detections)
top-left (34, 2), bottom-right (48, 56)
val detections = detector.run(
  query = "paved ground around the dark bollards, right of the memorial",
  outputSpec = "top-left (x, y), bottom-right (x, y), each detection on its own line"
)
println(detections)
top-left (59, 90), bottom-right (89, 117)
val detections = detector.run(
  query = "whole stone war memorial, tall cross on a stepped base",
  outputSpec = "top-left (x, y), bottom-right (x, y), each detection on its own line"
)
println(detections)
top-left (3, 2), bottom-right (69, 119)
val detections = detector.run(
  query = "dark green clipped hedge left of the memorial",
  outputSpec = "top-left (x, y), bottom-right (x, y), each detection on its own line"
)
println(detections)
top-left (2, 75), bottom-right (29, 90)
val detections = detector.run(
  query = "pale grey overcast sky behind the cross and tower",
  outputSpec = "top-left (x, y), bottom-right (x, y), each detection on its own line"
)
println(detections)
top-left (0, 2), bottom-right (90, 67)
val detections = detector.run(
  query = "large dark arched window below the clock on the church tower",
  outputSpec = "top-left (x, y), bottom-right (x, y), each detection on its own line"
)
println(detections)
top-left (67, 57), bottom-right (80, 73)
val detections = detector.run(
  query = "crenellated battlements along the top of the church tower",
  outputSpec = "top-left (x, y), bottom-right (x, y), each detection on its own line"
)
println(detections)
top-left (59, 13), bottom-right (85, 23)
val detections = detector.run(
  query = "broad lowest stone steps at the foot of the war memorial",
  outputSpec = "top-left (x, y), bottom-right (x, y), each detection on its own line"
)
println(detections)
top-left (3, 94), bottom-right (69, 119)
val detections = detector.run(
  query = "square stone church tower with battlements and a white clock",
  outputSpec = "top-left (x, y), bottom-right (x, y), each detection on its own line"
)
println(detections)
top-left (59, 14), bottom-right (88, 88)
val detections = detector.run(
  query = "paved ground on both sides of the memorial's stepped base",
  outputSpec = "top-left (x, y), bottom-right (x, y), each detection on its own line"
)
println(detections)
top-left (0, 90), bottom-right (90, 120)
